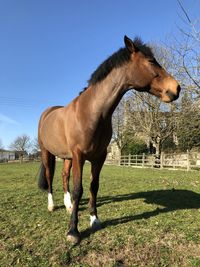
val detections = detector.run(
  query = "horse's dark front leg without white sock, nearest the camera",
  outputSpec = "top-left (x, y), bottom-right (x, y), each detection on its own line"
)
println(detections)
top-left (67, 149), bottom-right (84, 244)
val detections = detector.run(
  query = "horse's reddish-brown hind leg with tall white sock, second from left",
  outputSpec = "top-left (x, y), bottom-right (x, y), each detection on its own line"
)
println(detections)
top-left (62, 159), bottom-right (72, 213)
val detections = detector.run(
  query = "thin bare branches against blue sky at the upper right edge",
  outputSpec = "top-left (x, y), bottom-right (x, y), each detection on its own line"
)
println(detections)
top-left (168, 0), bottom-right (200, 94)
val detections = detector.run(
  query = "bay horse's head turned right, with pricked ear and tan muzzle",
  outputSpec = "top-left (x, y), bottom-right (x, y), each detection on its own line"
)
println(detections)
top-left (124, 36), bottom-right (181, 102)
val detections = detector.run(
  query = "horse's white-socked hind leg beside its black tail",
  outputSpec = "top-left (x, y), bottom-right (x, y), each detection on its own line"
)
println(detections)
top-left (41, 149), bottom-right (55, 211)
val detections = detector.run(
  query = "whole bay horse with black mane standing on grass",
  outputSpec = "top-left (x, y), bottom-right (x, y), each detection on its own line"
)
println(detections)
top-left (38, 36), bottom-right (180, 243)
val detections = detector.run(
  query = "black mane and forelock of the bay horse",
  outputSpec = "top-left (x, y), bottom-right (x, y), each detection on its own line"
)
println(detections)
top-left (81, 37), bottom-right (154, 93)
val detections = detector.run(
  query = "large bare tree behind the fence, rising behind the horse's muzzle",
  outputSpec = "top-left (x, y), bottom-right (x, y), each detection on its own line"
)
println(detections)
top-left (122, 45), bottom-right (180, 155)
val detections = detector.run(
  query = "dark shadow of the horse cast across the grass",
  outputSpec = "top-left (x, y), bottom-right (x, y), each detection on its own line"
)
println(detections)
top-left (81, 189), bottom-right (200, 239)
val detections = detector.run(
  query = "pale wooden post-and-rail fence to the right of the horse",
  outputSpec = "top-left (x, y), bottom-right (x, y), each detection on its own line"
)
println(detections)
top-left (106, 152), bottom-right (200, 171)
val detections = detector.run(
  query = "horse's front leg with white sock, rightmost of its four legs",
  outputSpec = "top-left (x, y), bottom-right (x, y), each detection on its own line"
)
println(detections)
top-left (89, 152), bottom-right (107, 230)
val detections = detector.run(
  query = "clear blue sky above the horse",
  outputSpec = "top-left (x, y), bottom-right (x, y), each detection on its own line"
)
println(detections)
top-left (0, 0), bottom-right (200, 148)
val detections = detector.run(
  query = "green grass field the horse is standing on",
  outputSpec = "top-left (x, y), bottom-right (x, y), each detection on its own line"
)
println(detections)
top-left (0, 163), bottom-right (200, 267)
